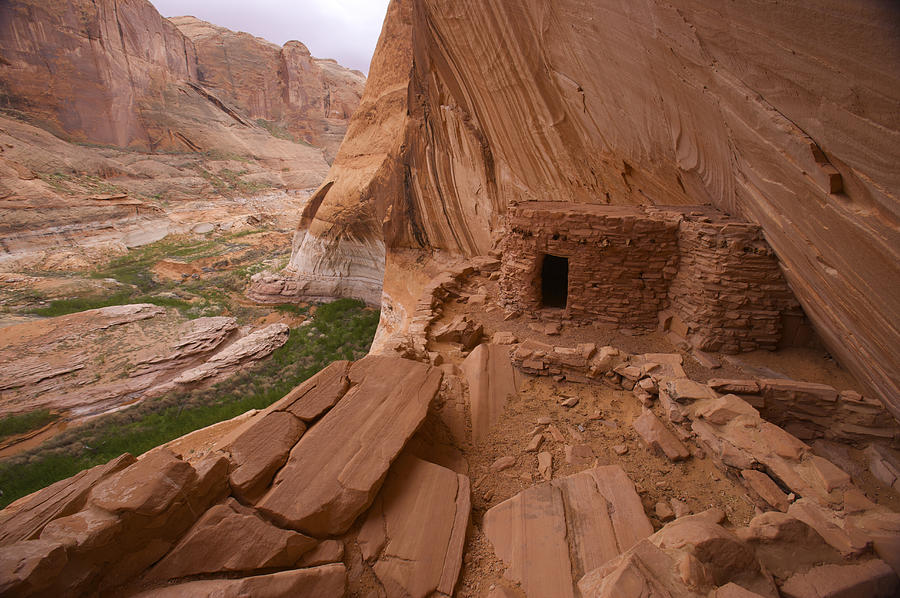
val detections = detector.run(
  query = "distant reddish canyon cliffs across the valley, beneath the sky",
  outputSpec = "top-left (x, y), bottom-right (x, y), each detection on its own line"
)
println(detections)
top-left (0, 0), bottom-right (365, 161)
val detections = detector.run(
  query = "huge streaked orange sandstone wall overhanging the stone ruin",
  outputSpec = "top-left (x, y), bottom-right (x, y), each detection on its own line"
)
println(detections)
top-left (287, 0), bottom-right (900, 415)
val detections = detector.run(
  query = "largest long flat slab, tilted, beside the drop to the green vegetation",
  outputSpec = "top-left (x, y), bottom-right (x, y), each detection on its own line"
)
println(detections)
top-left (257, 355), bottom-right (442, 536)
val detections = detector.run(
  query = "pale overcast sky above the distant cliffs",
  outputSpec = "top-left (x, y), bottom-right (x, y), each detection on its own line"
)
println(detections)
top-left (150, 0), bottom-right (389, 74)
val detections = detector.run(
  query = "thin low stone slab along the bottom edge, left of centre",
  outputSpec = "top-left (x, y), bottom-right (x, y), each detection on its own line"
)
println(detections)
top-left (134, 564), bottom-right (347, 598)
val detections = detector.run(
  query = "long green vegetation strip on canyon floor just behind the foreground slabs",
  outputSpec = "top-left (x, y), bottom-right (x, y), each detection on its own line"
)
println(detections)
top-left (0, 299), bottom-right (379, 507)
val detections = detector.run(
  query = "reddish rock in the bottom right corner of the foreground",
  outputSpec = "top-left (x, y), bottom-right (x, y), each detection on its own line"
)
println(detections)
top-left (781, 559), bottom-right (900, 598)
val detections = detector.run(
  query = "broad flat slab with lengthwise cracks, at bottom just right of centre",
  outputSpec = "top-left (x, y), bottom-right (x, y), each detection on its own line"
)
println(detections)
top-left (484, 466), bottom-right (653, 598)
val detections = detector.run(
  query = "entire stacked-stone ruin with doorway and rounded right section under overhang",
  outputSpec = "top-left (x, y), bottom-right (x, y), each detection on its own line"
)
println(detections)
top-left (500, 202), bottom-right (803, 354)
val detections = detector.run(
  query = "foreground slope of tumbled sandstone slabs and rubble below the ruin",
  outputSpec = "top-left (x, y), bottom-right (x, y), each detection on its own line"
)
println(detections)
top-left (0, 264), bottom-right (900, 598)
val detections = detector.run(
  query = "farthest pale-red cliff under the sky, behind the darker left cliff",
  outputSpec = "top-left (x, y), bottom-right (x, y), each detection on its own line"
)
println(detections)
top-left (169, 16), bottom-right (365, 158)
